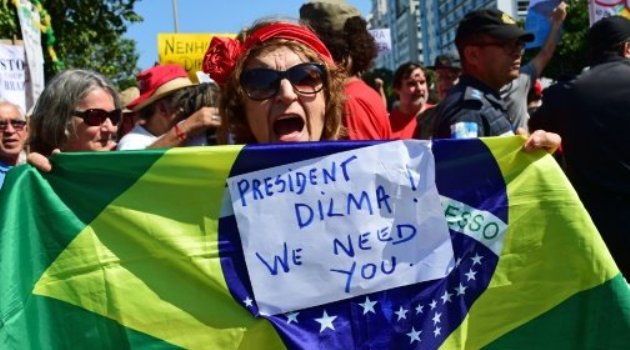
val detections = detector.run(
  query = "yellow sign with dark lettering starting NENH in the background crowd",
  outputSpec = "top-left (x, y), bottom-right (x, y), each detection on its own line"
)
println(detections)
top-left (157, 33), bottom-right (236, 81)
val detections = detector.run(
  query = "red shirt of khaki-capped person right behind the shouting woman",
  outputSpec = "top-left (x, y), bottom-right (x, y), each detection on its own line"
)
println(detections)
top-left (343, 79), bottom-right (392, 140)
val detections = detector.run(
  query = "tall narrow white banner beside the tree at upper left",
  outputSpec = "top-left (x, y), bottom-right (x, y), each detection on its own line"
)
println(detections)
top-left (18, 0), bottom-right (44, 109)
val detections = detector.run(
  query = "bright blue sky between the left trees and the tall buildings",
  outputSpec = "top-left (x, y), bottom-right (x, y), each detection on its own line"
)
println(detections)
top-left (126, 0), bottom-right (372, 69)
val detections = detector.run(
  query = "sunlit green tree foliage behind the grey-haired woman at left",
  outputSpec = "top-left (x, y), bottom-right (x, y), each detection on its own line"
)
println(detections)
top-left (0, 0), bottom-right (142, 89)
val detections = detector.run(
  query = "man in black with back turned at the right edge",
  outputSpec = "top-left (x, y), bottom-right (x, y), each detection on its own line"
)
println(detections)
top-left (529, 16), bottom-right (630, 278)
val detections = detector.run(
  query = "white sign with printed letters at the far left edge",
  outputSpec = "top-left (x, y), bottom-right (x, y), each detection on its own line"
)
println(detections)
top-left (0, 44), bottom-right (26, 113)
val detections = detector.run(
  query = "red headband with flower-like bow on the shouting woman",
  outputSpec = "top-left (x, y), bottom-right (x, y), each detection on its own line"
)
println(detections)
top-left (203, 23), bottom-right (334, 86)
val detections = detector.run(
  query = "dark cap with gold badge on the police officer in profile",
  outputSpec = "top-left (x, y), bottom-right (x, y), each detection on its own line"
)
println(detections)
top-left (455, 9), bottom-right (534, 42)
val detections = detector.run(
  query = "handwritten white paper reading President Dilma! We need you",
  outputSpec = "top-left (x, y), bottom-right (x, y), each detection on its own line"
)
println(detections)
top-left (228, 141), bottom-right (453, 315)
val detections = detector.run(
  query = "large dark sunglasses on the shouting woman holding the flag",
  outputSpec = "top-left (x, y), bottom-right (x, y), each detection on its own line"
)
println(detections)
top-left (240, 63), bottom-right (326, 101)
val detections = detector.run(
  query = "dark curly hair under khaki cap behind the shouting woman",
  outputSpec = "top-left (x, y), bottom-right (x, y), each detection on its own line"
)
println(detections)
top-left (310, 16), bottom-right (378, 76)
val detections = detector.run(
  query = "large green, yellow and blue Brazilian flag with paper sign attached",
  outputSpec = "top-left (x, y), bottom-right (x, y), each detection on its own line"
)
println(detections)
top-left (0, 137), bottom-right (630, 349)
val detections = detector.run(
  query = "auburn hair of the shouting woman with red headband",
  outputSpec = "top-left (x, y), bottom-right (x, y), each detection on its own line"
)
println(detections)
top-left (217, 21), bottom-right (346, 144)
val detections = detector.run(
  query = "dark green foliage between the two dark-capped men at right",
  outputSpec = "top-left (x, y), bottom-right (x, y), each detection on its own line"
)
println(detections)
top-left (523, 1), bottom-right (589, 80)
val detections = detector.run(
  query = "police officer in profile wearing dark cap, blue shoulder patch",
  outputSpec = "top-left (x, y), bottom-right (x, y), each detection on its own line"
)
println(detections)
top-left (433, 9), bottom-right (534, 138)
